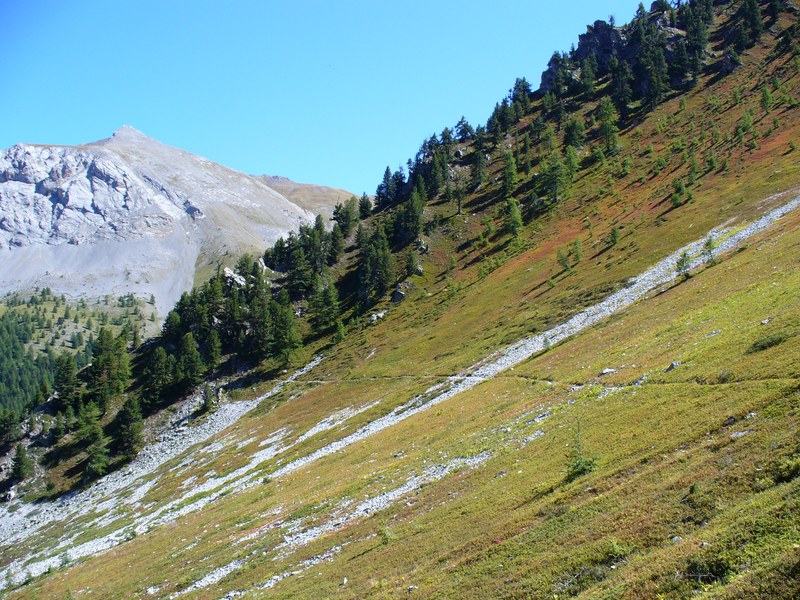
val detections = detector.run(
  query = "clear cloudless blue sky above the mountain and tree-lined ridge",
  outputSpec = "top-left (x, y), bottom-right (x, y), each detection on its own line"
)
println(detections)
top-left (0, 0), bottom-right (638, 193)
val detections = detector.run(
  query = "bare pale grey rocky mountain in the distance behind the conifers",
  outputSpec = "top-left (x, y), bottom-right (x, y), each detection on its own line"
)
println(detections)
top-left (0, 126), bottom-right (346, 308)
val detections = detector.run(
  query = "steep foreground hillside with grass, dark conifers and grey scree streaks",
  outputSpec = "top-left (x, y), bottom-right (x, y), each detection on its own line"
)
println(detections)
top-left (0, 0), bottom-right (800, 599)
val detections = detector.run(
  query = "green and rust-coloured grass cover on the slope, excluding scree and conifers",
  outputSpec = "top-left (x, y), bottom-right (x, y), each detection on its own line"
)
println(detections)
top-left (6, 5), bottom-right (800, 598)
